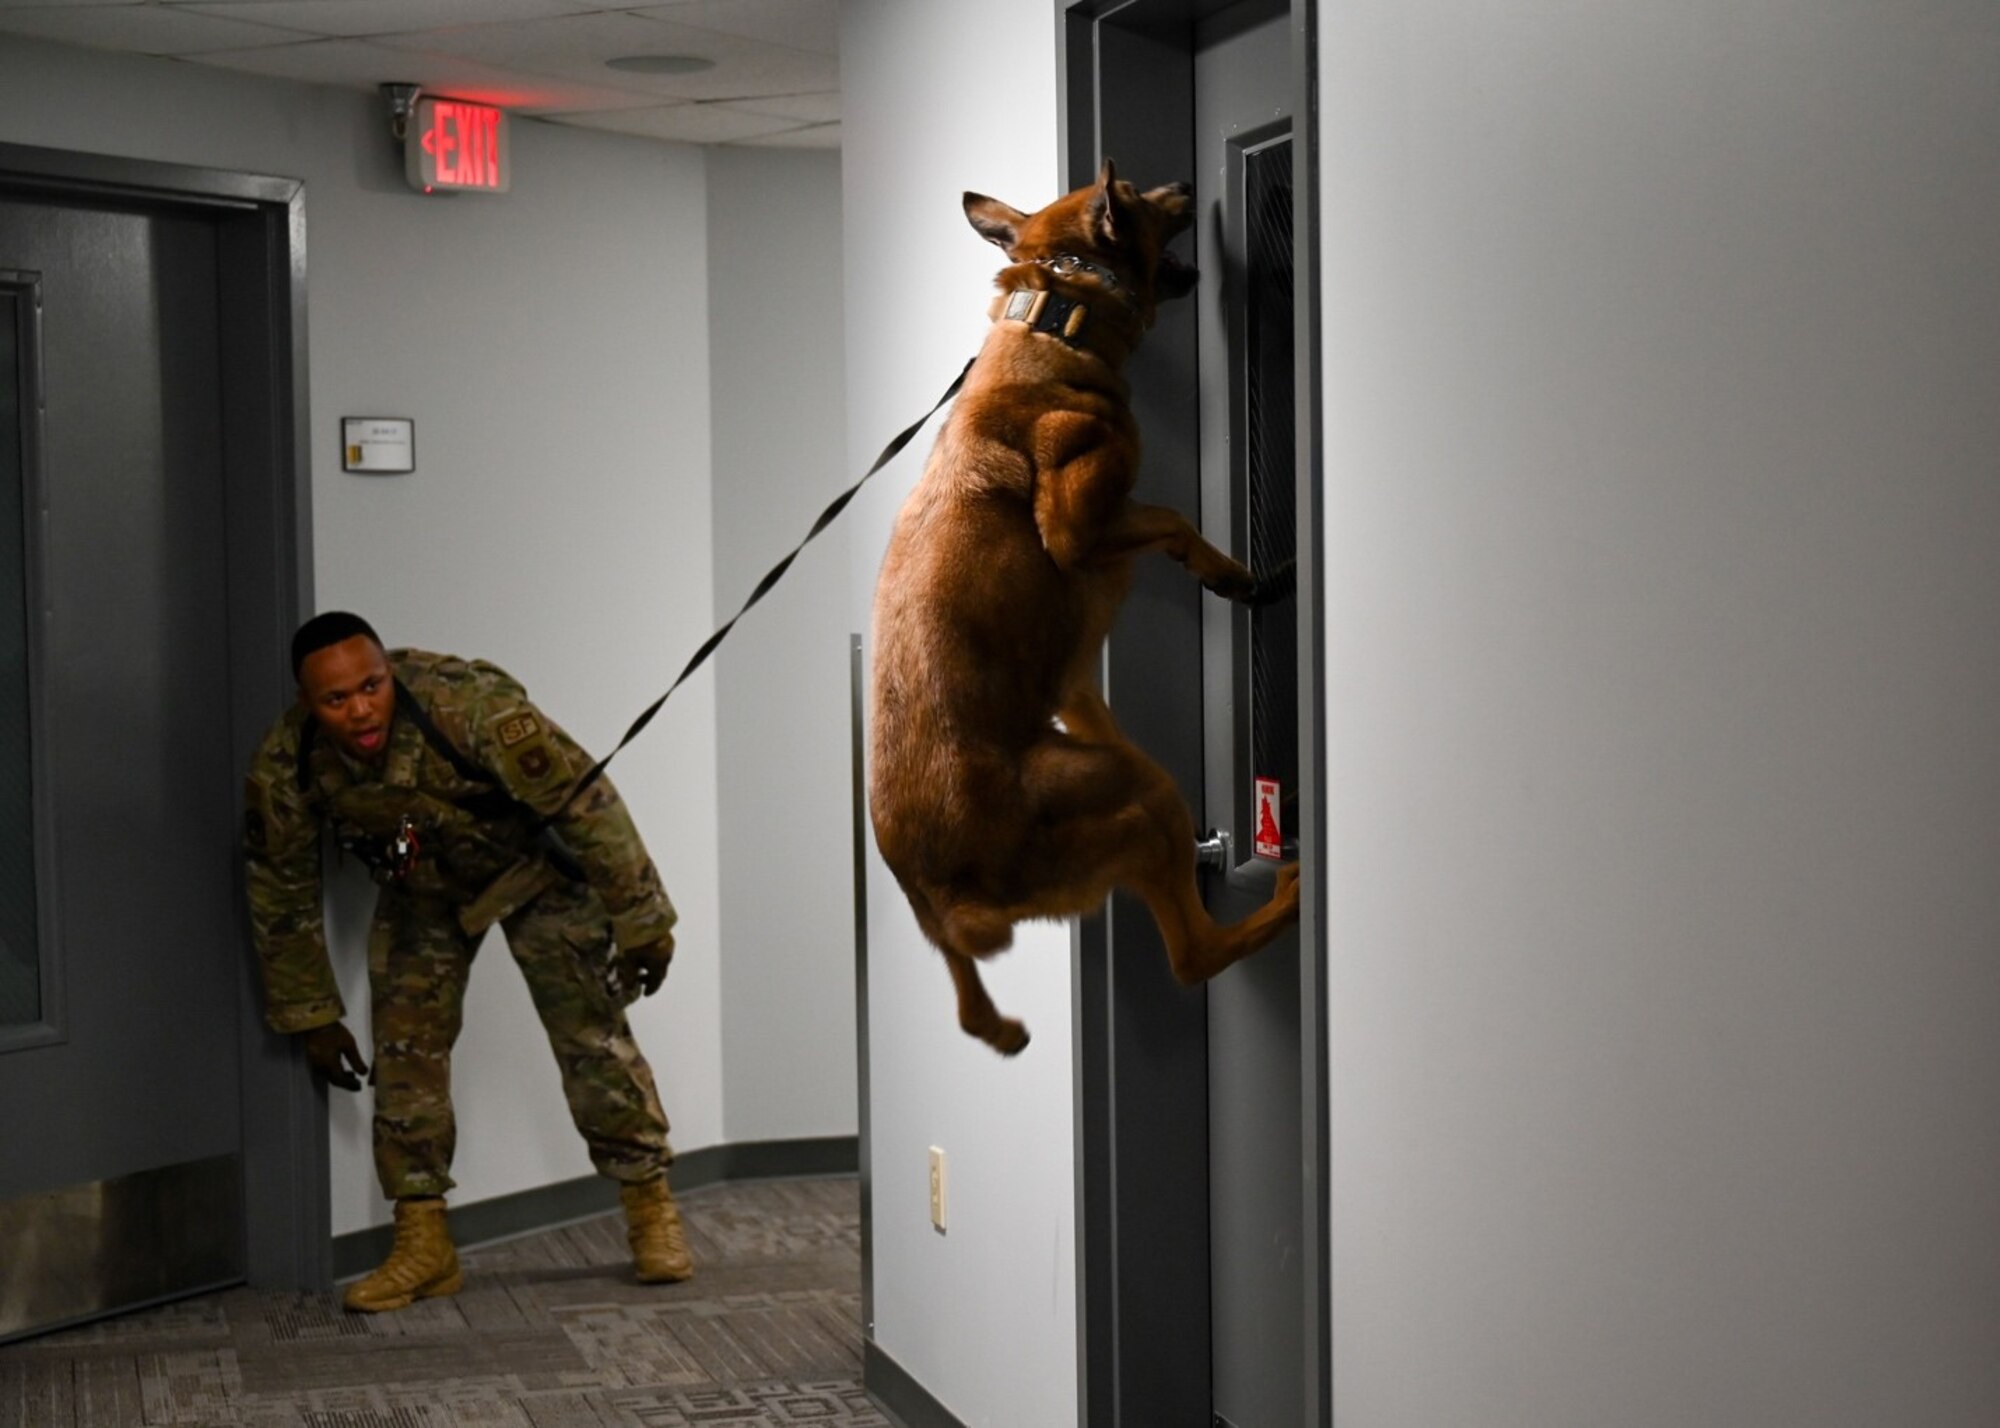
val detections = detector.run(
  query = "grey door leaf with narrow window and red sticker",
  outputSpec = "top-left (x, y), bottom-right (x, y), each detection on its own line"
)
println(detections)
top-left (1194, 6), bottom-right (1306, 1428)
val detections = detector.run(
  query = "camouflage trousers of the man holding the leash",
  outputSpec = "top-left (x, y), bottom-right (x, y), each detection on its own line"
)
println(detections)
top-left (368, 884), bottom-right (672, 1200)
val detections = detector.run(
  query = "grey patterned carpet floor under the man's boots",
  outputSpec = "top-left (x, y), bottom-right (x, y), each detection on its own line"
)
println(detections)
top-left (0, 1178), bottom-right (892, 1428)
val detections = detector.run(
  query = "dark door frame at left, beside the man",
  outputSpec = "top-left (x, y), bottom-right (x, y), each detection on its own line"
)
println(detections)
top-left (0, 144), bottom-right (332, 1288)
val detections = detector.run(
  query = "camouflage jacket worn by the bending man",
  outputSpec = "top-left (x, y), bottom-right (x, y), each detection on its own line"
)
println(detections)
top-left (244, 650), bottom-right (674, 1032)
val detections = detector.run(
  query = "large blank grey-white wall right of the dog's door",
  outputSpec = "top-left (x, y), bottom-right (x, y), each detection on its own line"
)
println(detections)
top-left (1320, 0), bottom-right (2000, 1428)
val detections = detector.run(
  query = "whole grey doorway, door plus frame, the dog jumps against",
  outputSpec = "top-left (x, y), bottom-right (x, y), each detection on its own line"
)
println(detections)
top-left (1062, 0), bottom-right (1332, 1428)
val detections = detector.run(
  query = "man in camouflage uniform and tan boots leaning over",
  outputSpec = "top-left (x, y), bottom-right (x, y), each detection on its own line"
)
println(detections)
top-left (244, 612), bottom-right (694, 1310)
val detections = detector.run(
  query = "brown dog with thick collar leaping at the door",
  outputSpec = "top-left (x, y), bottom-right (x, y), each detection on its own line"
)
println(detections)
top-left (868, 162), bottom-right (1298, 1056)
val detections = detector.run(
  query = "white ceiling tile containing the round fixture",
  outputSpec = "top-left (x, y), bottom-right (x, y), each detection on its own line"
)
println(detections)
top-left (380, 12), bottom-right (838, 100)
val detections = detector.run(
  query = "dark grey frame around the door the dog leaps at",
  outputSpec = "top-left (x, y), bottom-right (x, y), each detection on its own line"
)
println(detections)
top-left (1054, 0), bottom-right (1332, 1428)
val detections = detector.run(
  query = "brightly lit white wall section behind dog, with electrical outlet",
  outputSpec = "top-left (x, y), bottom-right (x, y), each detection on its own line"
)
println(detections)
top-left (840, 0), bottom-right (1076, 1428)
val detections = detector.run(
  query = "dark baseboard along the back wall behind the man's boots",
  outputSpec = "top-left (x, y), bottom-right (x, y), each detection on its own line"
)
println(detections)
top-left (334, 1136), bottom-right (860, 1280)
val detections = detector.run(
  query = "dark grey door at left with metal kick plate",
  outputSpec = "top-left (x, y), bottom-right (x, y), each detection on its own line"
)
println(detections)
top-left (0, 196), bottom-right (246, 1338)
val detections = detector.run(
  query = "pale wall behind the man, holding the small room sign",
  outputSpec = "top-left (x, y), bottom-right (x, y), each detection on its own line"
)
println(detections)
top-left (0, 38), bottom-right (722, 1232)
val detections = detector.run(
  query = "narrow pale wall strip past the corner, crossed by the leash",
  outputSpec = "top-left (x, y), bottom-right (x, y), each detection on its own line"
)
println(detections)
top-left (706, 148), bottom-right (860, 1142)
